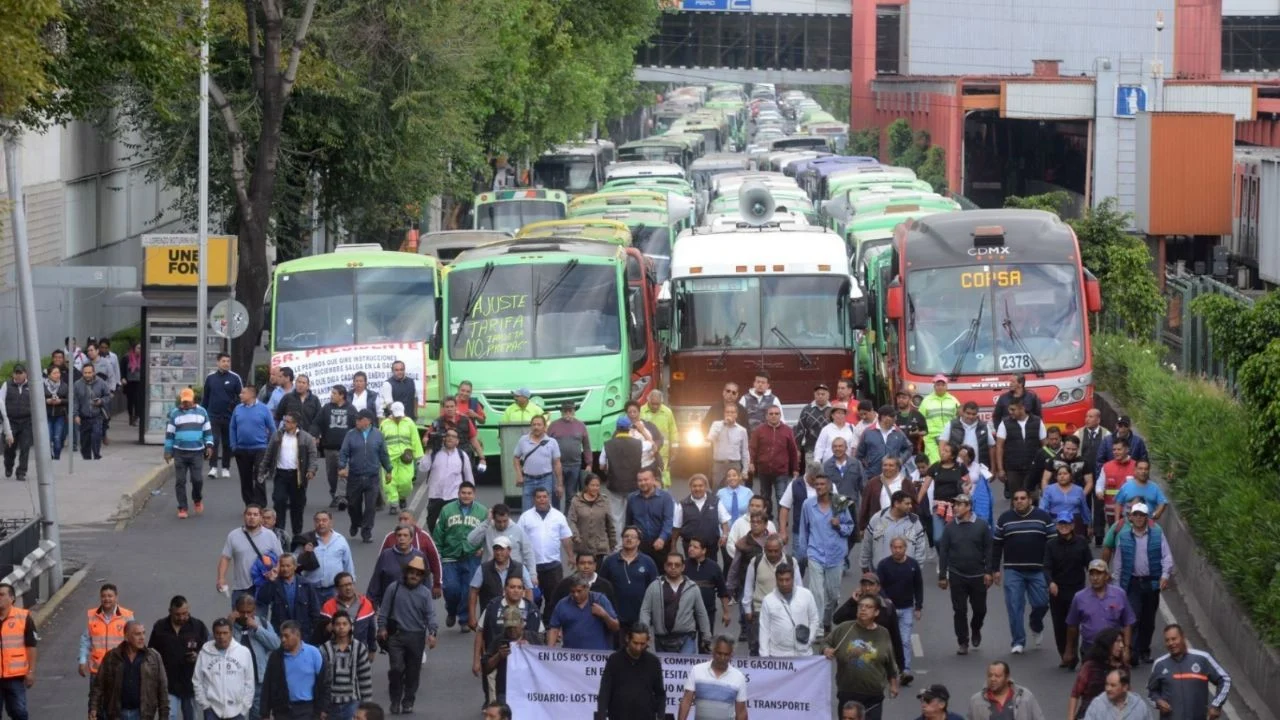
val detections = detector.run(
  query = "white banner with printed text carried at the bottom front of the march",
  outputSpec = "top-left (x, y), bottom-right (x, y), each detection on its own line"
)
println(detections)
top-left (507, 646), bottom-right (833, 720)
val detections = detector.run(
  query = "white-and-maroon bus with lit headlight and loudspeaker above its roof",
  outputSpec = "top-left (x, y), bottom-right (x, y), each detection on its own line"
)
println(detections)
top-left (663, 223), bottom-right (867, 459)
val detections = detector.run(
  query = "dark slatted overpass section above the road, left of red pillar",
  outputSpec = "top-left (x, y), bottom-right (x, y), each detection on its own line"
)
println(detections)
top-left (635, 0), bottom-right (852, 87)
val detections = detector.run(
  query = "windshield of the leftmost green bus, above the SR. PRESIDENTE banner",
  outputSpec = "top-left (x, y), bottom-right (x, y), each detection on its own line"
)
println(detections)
top-left (271, 268), bottom-right (435, 352)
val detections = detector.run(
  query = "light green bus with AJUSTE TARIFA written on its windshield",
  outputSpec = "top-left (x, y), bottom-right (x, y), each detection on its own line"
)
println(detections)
top-left (442, 237), bottom-right (662, 461)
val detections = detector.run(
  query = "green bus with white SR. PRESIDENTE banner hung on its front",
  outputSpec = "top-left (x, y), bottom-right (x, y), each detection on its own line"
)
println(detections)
top-left (270, 245), bottom-right (440, 425)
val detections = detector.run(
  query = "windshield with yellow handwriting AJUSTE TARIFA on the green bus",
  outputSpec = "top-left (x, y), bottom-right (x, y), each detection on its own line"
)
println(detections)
top-left (448, 260), bottom-right (622, 360)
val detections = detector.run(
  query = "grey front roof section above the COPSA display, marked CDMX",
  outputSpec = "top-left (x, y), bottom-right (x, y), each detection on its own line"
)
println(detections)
top-left (899, 210), bottom-right (1080, 268)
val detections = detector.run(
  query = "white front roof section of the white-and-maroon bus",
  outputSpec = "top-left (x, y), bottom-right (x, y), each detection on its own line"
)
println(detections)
top-left (671, 227), bottom-right (849, 278)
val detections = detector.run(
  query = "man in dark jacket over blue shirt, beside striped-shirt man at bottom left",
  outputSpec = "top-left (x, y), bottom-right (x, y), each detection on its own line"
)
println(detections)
top-left (261, 620), bottom-right (329, 720)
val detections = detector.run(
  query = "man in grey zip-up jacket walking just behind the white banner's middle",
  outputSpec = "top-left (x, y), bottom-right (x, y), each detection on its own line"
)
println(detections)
top-left (640, 552), bottom-right (712, 655)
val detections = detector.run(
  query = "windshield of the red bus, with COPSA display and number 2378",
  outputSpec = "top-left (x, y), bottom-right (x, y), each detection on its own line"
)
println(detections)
top-left (906, 264), bottom-right (1085, 375)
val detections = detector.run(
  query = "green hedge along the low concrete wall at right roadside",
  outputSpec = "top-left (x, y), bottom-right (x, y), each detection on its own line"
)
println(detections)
top-left (1093, 334), bottom-right (1280, 647)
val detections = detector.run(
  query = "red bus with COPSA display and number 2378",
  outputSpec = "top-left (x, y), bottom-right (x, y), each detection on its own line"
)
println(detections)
top-left (883, 210), bottom-right (1102, 432)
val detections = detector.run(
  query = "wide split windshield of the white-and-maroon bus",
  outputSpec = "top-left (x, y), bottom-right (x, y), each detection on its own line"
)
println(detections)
top-left (676, 275), bottom-right (851, 350)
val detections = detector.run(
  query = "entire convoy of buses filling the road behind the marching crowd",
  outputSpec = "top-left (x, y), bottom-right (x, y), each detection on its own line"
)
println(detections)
top-left (270, 85), bottom-right (1101, 486)
